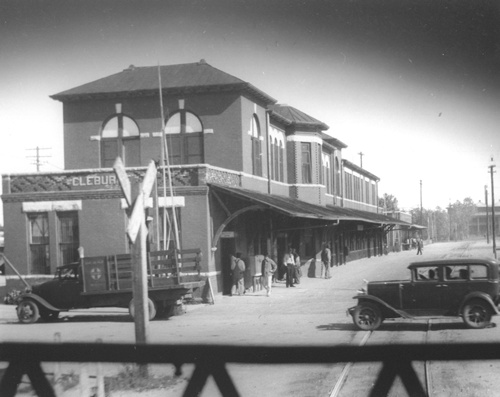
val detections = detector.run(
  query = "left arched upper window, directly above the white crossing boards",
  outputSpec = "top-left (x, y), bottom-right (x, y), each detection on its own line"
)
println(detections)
top-left (101, 114), bottom-right (141, 167)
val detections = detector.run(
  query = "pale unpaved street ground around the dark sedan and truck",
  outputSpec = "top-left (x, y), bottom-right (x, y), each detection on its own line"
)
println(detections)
top-left (0, 242), bottom-right (500, 397)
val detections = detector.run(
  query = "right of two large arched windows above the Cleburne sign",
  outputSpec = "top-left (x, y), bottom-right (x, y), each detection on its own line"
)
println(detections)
top-left (165, 109), bottom-right (205, 164)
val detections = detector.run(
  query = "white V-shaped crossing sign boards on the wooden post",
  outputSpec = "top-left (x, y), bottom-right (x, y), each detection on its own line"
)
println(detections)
top-left (113, 157), bottom-right (156, 243)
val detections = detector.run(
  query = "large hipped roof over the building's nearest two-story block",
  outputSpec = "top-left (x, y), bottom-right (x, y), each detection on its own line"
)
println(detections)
top-left (51, 59), bottom-right (276, 104)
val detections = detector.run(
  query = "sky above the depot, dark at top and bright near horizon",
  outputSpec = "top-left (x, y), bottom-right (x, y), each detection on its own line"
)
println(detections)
top-left (0, 0), bottom-right (500, 220)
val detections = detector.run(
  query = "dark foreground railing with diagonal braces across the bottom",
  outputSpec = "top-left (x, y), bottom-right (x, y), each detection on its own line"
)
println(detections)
top-left (0, 343), bottom-right (500, 397)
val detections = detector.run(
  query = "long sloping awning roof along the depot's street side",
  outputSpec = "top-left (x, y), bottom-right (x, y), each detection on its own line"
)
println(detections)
top-left (210, 184), bottom-right (410, 226)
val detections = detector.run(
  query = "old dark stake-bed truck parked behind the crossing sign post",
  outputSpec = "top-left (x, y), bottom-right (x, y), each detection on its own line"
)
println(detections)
top-left (17, 249), bottom-right (205, 324)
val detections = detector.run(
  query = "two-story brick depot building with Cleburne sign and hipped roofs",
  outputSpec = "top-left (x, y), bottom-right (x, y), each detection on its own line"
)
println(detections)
top-left (2, 60), bottom-right (404, 292)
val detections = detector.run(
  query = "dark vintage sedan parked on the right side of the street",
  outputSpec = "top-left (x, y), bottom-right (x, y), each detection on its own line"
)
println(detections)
top-left (348, 258), bottom-right (500, 330)
